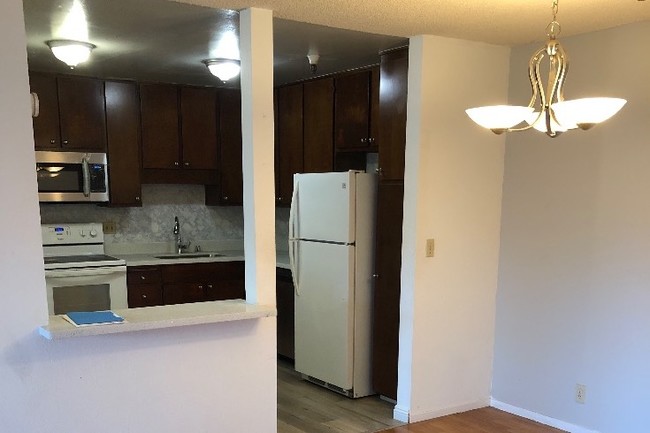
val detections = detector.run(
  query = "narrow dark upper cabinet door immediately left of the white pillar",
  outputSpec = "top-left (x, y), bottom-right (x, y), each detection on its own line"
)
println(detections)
top-left (219, 89), bottom-right (243, 205)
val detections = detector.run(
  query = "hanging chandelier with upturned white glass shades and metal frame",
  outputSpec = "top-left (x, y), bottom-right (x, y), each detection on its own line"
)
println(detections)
top-left (465, 0), bottom-right (627, 138)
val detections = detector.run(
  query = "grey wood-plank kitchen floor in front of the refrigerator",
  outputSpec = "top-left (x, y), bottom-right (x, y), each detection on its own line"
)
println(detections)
top-left (278, 360), bottom-right (403, 433)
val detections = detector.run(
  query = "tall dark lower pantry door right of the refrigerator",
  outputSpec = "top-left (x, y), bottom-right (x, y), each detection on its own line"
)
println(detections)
top-left (372, 182), bottom-right (404, 399)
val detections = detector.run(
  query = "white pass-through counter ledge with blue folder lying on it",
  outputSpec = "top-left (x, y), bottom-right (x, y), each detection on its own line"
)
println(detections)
top-left (38, 300), bottom-right (277, 340)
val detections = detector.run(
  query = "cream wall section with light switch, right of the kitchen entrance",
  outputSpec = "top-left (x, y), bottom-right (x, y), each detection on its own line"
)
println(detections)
top-left (395, 36), bottom-right (510, 421)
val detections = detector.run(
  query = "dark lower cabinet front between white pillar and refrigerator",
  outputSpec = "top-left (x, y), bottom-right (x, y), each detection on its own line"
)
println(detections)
top-left (275, 268), bottom-right (295, 359)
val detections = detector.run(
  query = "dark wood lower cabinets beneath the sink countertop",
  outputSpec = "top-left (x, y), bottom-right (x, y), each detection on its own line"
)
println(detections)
top-left (127, 262), bottom-right (246, 308)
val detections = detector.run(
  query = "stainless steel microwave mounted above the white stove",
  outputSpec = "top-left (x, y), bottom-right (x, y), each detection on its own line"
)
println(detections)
top-left (36, 151), bottom-right (108, 202)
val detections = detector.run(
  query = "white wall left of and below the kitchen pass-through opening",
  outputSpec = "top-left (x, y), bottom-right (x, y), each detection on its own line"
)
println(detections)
top-left (0, 0), bottom-right (276, 433)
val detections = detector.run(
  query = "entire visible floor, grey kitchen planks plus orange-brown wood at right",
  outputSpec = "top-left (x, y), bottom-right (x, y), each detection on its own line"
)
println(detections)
top-left (278, 359), bottom-right (563, 433)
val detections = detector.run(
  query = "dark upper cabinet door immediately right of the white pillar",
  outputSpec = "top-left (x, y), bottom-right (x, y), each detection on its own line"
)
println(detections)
top-left (278, 84), bottom-right (303, 206)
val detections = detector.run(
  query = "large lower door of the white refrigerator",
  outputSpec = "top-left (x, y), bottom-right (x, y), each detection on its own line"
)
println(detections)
top-left (295, 241), bottom-right (354, 390)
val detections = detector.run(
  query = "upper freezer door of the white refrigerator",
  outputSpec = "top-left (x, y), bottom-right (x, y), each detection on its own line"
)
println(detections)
top-left (290, 172), bottom-right (356, 243)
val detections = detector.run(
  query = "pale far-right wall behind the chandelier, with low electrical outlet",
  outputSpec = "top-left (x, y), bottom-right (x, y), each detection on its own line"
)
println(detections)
top-left (493, 22), bottom-right (650, 433)
